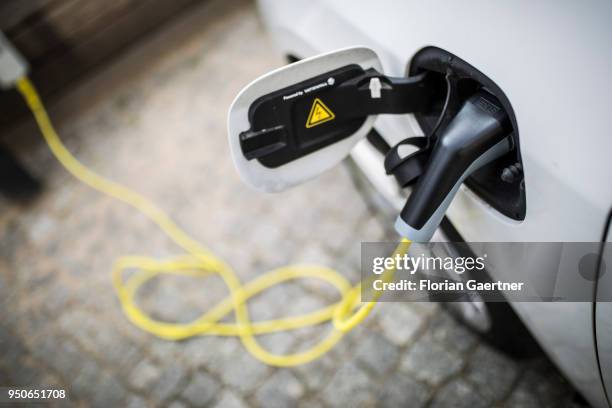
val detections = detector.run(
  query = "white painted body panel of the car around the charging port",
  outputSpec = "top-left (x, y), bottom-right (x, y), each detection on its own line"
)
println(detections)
top-left (259, 0), bottom-right (612, 406)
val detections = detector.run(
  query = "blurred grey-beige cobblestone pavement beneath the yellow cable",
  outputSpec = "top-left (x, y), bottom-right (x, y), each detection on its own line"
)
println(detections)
top-left (0, 1), bottom-right (584, 407)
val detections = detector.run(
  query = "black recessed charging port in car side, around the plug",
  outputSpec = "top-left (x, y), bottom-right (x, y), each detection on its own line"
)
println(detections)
top-left (409, 47), bottom-right (526, 221)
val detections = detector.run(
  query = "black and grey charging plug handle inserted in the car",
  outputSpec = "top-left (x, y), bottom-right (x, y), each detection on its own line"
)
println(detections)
top-left (395, 91), bottom-right (512, 242)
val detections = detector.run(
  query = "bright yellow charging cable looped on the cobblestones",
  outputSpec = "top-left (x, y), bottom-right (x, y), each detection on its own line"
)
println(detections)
top-left (17, 77), bottom-right (410, 367)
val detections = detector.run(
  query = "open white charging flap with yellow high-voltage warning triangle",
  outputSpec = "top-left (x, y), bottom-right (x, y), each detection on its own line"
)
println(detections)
top-left (228, 47), bottom-right (384, 192)
